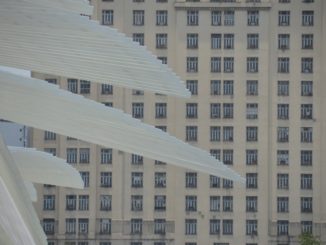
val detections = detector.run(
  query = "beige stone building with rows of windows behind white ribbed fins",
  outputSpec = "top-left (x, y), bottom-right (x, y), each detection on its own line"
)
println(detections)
top-left (31, 0), bottom-right (326, 245)
